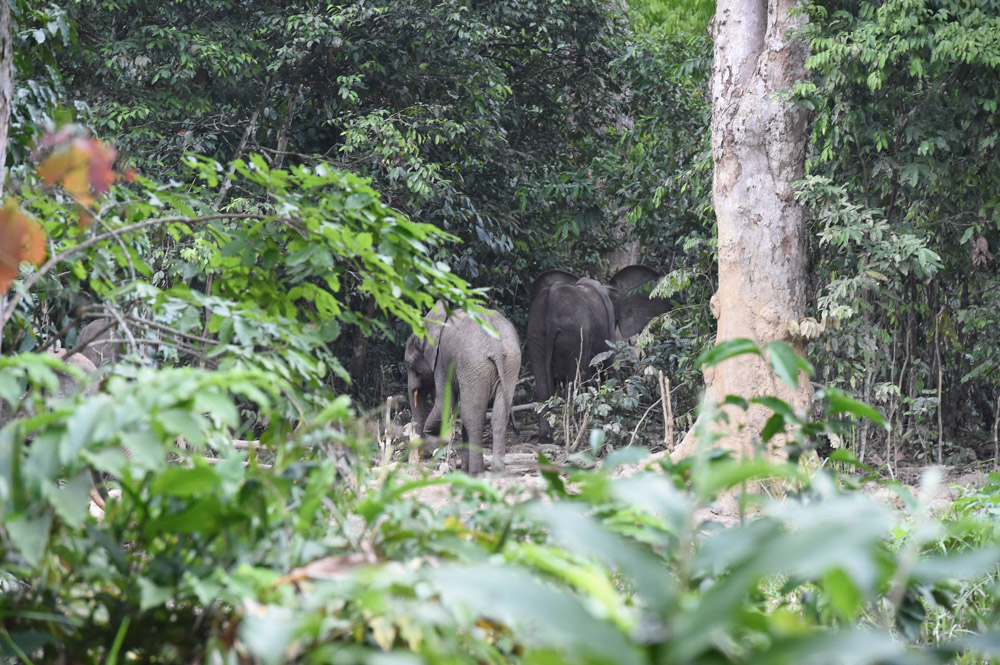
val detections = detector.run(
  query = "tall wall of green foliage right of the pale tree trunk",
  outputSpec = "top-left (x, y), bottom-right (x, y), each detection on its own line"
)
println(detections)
top-left (797, 0), bottom-right (1000, 464)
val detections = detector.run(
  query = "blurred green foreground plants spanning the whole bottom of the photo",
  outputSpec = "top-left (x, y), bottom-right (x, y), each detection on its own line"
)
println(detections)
top-left (0, 344), bottom-right (1000, 663)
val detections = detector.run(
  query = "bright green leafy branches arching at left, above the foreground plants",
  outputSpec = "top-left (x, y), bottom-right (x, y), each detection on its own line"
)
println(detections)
top-left (4, 149), bottom-right (475, 403)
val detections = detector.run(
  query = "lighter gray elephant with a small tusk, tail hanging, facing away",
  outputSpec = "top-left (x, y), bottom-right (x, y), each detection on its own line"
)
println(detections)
top-left (405, 302), bottom-right (521, 474)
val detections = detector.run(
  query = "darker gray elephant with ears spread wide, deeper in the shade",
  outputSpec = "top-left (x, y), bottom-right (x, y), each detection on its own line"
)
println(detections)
top-left (528, 265), bottom-right (670, 441)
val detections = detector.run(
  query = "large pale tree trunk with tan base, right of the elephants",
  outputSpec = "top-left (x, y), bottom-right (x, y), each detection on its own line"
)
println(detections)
top-left (675, 0), bottom-right (810, 456)
